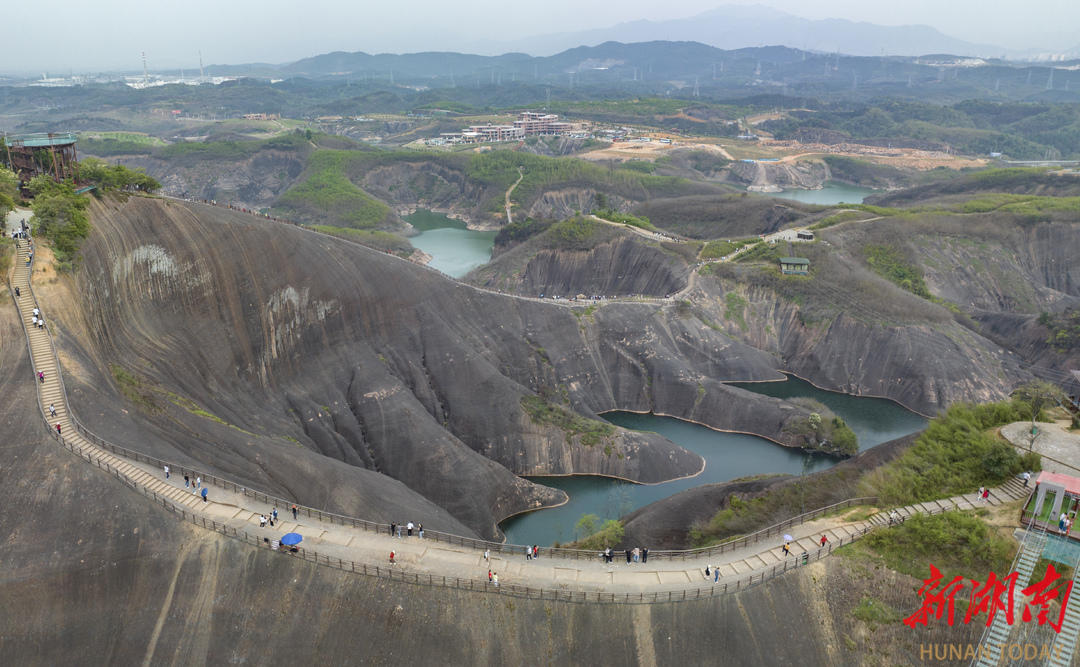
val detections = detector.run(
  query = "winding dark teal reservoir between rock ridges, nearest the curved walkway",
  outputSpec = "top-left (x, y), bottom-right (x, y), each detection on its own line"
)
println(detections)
top-left (500, 378), bottom-right (927, 546)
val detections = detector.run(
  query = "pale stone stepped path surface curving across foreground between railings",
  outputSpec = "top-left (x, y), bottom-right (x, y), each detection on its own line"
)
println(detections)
top-left (12, 235), bottom-right (1028, 593)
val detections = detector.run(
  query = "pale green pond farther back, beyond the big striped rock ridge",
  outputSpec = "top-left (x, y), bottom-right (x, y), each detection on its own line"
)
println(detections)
top-left (403, 208), bottom-right (498, 277)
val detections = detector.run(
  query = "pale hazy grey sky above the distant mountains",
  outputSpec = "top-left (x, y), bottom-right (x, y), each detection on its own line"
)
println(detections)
top-left (0, 0), bottom-right (1080, 76)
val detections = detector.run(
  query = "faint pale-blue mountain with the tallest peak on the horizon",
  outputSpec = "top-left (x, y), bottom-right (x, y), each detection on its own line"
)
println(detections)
top-left (464, 5), bottom-right (1008, 57)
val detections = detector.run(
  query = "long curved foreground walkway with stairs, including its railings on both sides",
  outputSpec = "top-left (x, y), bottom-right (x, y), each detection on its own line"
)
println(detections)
top-left (11, 219), bottom-right (1028, 603)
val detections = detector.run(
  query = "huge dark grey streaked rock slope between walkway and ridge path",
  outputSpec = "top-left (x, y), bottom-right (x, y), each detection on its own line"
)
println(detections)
top-left (54, 198), bottom-right (812, 537)
